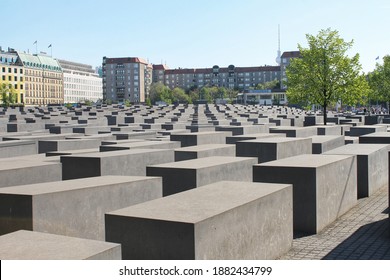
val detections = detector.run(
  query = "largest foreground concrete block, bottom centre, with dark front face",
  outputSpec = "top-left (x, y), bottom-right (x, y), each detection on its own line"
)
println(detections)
top-left (106, 181), bottom-right (292, 260)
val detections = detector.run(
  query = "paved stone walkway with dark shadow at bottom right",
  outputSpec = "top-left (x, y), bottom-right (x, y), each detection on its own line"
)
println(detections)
top-left (280, 188), bottom-right (390, 260)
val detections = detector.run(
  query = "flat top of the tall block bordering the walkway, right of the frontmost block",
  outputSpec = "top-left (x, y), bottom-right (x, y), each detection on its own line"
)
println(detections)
top-left (255, 154), bottom-right (353, 168)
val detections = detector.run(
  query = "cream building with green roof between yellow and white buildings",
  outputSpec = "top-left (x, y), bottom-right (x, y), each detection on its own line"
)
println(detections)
top-left (16, 51), bottom-right (64, 105)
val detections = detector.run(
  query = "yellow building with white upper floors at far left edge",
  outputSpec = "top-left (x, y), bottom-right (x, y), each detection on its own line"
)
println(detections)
top-left (0, 48), bottom-right (25, 103)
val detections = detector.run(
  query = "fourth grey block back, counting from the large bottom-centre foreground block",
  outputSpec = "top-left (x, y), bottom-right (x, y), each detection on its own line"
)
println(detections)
top-left (171, 131), bottom-right (232, 147)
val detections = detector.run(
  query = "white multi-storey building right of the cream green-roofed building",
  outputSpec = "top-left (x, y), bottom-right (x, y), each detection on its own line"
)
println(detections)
top-left (58, 59), bottom-right (103, 103)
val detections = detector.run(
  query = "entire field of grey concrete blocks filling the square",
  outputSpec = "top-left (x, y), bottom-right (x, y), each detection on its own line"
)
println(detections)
top-left (0, 104), bottom-right (390, 260)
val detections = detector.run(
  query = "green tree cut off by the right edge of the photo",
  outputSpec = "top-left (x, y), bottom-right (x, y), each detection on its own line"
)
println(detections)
top-left (368, 55), bottom-right (390, 107)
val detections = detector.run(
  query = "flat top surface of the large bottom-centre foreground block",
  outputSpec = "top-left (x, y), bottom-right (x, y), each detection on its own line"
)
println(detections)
top-left (108, 181), bottom-right (291, 223)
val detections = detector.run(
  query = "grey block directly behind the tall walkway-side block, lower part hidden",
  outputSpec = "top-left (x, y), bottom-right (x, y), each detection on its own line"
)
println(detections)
top-left (236, 137), bottom-right (312, 163)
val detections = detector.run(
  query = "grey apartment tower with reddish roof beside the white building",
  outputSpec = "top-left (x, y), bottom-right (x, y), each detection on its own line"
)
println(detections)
top-left (103, 57), bottom-right (153, 103)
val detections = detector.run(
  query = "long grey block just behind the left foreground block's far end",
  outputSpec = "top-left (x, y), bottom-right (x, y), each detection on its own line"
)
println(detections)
top-left (61, 149), bottom-right (174, 180)
